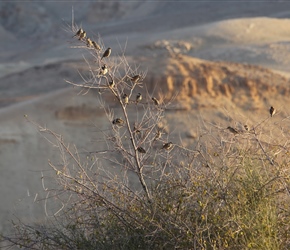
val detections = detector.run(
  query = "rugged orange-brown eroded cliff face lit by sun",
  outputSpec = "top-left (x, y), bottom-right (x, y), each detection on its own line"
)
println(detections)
top-left (142, 55), bottom-right (290, 108)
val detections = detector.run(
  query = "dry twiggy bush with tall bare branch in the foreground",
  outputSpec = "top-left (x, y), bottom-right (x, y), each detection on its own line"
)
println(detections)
top-left (2, 22), bottom-right (290, 249)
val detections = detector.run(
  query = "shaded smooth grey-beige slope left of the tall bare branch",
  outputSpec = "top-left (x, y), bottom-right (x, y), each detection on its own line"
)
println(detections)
top-left (0, 89), bottom-right (110, 230)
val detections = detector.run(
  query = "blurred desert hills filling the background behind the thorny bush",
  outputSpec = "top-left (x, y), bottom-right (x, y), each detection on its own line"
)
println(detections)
top-left (0, 1), bottom-right (290, 238)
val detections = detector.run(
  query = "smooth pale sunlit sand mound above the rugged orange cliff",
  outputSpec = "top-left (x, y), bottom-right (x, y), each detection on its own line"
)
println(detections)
top-left (138, 17), bottom-right (290, 72)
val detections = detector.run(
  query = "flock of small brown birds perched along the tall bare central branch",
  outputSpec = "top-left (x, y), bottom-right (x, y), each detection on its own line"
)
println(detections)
top-left (73, 28), bottom-right (174, 154)
